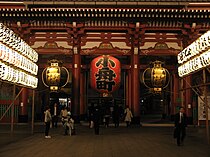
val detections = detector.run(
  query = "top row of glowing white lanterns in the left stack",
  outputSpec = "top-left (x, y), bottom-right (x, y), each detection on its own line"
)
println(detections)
top-left (0, 23), bottom-right (38, 62)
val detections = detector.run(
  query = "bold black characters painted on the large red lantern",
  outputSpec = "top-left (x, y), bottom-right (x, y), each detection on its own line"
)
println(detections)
top-left (95, 56), bottom-right (116, 92)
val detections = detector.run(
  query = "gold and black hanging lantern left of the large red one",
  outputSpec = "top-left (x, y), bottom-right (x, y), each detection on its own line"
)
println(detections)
top-left (42, 60), bottom-right (69, 91)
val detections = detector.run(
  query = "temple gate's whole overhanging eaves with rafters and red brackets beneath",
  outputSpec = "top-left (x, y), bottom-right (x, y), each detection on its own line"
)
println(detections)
top-left (0, 0), bottom-right (210, 50)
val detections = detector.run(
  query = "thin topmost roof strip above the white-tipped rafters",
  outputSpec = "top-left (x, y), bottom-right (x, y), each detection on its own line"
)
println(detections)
top-left (0, 0), bottom-right (209, 7)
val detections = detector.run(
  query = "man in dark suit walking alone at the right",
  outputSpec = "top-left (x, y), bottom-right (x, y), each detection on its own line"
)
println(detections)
top-left (174, 107), bottom-right (187, 146)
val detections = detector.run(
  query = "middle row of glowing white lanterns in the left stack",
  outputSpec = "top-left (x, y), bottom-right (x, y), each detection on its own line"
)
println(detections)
top-left (0, 42), bottom-right (38, 75)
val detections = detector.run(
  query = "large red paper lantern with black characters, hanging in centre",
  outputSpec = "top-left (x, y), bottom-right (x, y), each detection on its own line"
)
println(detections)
top-left (90, 55), bottom-right (121, 95)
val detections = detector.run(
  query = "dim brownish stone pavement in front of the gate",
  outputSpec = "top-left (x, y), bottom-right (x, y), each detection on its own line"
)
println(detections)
top-left (0, 124), bottom-right (210, 157)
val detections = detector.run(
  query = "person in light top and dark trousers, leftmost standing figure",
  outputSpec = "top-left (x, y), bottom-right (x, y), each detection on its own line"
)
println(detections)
top-left (44, 106), bottom-right (52, 138)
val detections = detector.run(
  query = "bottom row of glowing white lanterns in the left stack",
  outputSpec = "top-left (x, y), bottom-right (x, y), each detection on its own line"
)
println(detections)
top-left (0, 61), bottom-right (38, 88)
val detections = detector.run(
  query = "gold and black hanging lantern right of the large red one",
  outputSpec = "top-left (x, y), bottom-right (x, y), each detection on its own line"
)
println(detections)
top-left (143, 61), bottom-right (170, 93)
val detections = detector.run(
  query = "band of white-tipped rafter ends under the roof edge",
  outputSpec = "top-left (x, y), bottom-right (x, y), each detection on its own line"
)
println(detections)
top-left (0, 7), bottom-right (210, 21)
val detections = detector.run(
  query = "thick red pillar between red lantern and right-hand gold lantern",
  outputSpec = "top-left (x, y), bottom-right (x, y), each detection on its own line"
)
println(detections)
top-left (131, 49), bottom-right (140, 118)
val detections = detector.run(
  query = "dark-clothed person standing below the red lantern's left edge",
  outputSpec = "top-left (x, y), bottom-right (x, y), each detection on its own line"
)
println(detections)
top-left (93, 106), bottom-right (101, 135)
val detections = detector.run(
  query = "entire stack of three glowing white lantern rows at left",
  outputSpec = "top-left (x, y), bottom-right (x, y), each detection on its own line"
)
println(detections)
top-left (0, 23), bottom-right (38, 88)
